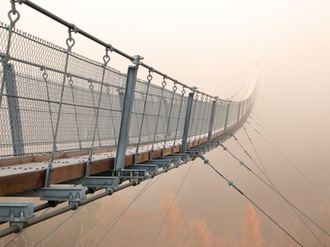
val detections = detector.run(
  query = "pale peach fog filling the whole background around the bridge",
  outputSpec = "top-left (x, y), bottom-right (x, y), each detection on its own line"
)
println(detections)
top-left (0, 0), bottom-right (330, 247)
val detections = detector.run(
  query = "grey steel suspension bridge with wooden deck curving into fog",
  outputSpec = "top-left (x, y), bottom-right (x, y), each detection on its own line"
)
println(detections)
top-left (0, 0), bottom-right (327, 245)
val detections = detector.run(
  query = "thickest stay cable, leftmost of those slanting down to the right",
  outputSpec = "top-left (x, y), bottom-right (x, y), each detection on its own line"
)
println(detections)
top-left (199, 155), bottom-right (303, 246)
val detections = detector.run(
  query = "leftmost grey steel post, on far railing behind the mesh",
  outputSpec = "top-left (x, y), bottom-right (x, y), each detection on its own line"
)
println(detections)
top-left (3, 63), bottom-right (24, 156)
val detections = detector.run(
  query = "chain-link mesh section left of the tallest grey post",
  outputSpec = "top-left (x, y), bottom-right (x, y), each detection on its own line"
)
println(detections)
top-left (0, 23), bottom-right (126, 157)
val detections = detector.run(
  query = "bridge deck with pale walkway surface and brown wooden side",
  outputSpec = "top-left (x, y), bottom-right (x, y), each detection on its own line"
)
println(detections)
top-left (0, 129), bottom-right (229, 196)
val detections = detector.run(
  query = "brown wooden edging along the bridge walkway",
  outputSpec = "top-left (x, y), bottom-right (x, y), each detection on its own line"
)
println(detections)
top-left (0, 128), bottom-right (241, 196)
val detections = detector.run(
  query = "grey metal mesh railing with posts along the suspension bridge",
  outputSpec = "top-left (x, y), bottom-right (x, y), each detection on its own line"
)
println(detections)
top-left (0, 1), bottom-right (254, 164)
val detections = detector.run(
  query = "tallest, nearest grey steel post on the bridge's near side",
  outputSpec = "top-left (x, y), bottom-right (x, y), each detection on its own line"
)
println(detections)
top-left (114, 64), bottom-right (138, 171)
